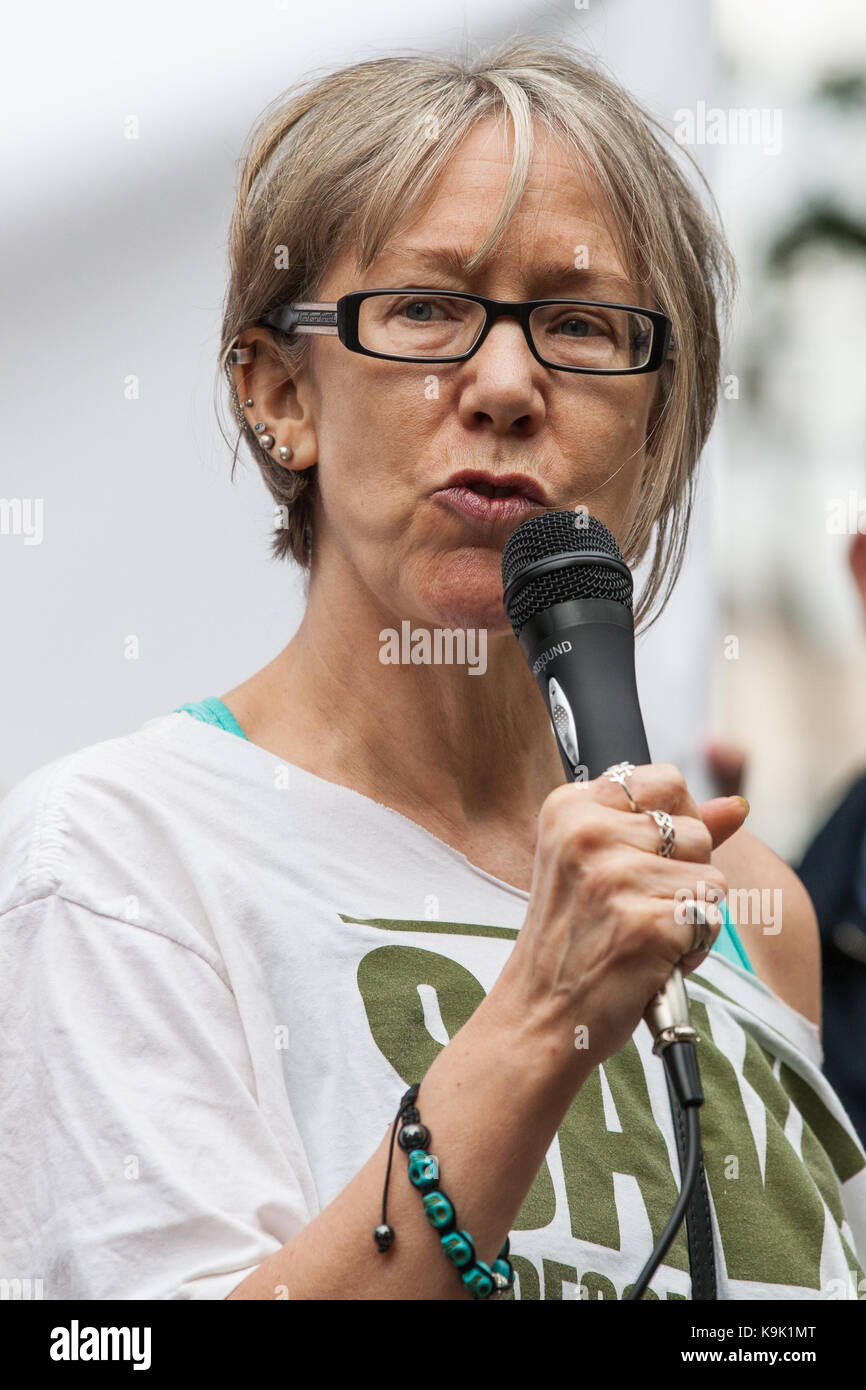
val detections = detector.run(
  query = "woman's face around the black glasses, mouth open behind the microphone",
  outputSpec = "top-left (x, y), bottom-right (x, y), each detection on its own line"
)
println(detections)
top-left (292, 121), bottom-right (657, 635)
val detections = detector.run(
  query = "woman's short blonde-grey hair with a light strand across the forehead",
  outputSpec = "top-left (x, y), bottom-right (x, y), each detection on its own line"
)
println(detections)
top-left (220, 39), bottom-right (737, 626)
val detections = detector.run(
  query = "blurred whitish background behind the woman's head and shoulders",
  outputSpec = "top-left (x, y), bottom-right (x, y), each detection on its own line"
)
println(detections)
top-left (0, 0), bottom-right (866, 856)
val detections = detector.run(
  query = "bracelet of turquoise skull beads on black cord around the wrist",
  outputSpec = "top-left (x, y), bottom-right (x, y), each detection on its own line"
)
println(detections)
top-left (373, 1084), bottom-right (514, 1298)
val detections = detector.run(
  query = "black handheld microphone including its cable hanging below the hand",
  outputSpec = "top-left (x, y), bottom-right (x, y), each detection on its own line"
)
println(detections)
top-left (502, 512), bottom-right (716, 1301)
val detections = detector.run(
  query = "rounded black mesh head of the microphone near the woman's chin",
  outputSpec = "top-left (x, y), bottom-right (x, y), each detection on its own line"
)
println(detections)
top-left (502, 512), bottom-right (632, 635)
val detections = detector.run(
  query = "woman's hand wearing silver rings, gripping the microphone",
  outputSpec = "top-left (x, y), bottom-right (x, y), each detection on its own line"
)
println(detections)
top-left (489, 763), bottom-right (748, 1084)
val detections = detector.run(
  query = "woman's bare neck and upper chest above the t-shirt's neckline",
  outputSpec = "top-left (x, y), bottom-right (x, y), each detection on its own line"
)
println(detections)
top-left (224, 575), bottom-right (564, 838)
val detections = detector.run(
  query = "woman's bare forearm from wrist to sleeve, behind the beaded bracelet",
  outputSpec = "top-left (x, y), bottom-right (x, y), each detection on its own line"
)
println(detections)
top-left (223, 991), bottom-right (591, 1300)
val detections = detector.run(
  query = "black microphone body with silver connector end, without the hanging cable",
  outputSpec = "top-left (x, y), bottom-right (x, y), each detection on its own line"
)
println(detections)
top-left (502, 512), bottom-right (701, 1061)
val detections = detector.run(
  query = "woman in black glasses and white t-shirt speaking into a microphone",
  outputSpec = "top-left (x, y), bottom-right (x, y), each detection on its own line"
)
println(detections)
top-left (1, 40), bottom-right (866, 1300)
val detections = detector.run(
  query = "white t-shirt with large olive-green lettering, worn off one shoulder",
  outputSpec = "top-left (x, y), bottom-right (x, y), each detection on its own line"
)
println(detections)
top-left (0, 713), bottom-right (866, 1300)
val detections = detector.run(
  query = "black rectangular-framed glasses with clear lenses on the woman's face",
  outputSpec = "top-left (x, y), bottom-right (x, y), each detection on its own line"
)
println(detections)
top-left (260, 289), bottom-right (674, 377)
